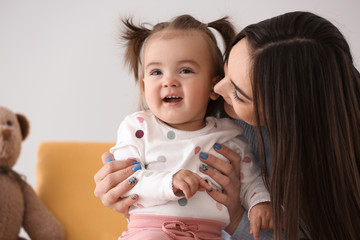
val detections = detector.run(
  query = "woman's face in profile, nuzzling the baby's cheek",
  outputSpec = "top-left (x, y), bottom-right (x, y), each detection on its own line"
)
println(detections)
top-left (214, 38), bottom-right (256, 125)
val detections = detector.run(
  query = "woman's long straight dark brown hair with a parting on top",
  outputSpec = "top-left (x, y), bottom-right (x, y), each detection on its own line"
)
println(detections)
top-left (228, 12), bottom-right (360, 239)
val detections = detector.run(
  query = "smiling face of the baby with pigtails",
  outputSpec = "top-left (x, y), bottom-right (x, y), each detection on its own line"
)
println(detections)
top-left (143, 30), bottom-right (215, 131)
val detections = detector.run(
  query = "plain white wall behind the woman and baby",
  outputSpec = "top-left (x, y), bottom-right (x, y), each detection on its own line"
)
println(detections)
top-left (0, 0), bottom-right (360, 189)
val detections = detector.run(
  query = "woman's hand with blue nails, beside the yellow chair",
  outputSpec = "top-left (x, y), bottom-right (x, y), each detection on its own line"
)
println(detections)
top-left (94, 152), bottom-right (140, 218)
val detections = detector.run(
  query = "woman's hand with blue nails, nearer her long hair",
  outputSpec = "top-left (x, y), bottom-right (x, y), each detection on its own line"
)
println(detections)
top-left (200, 144), bottom-right (245, 235)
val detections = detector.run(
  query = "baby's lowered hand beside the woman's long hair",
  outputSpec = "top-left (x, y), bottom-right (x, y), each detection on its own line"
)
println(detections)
top-left (250, 202), bottom-right (274, 239)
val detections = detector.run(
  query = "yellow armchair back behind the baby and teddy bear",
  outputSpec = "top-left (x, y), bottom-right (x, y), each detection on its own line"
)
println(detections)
top-left (35, 142), bottom-right (127, 240)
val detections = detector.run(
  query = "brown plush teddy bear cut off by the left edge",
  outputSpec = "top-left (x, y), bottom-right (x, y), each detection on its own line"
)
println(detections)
top-left (0, 106), bottom-right (65, 240)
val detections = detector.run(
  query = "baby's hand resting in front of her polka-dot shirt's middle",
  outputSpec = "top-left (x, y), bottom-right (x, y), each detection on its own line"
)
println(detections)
top-left (173, 169), bottom-right (212, 199)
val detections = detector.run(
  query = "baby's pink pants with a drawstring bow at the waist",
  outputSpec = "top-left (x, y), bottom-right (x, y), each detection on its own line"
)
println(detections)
top-left (118, 214), bottom-right (225, 240)
